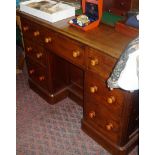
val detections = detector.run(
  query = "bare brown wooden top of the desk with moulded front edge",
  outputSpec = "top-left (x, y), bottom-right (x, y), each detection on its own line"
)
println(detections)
top-left (17, 11), bottom-right (133, 59)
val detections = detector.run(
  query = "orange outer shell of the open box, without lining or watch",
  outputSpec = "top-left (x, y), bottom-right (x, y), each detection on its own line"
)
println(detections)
top-left (69, 0), bottom-right (103, 31)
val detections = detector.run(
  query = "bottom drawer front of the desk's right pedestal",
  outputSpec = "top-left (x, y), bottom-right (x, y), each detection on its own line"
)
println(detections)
top-left (85, 102), bottom-right (121, 143)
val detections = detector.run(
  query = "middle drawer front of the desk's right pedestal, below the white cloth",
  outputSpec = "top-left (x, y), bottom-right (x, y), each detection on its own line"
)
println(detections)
top-left (85, 72), bottom-right (124, 118)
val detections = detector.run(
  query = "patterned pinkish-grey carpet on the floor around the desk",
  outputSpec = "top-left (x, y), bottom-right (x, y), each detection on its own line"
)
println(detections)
top-left (16, 65), bottom-right (137, 155)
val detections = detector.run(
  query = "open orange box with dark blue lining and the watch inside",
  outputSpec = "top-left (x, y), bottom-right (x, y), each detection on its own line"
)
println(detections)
top-left (69, 0), bottom-right (103, 31)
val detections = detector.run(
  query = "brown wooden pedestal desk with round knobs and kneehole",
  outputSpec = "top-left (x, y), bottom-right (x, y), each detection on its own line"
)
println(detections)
top-left (17, 11), bottom-right (139, 155)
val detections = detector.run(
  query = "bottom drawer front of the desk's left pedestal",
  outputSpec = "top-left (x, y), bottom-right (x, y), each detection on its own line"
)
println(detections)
top-left (26, 57), bottom-right (48, 89)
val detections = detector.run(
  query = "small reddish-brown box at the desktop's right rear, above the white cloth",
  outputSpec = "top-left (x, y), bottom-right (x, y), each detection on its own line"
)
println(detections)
top-left (115, 22), bottom-right (139, 37)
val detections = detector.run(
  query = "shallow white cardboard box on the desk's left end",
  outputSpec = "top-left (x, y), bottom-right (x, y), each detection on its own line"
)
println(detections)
top-left (20, 0), bottom-right (75, 23)
